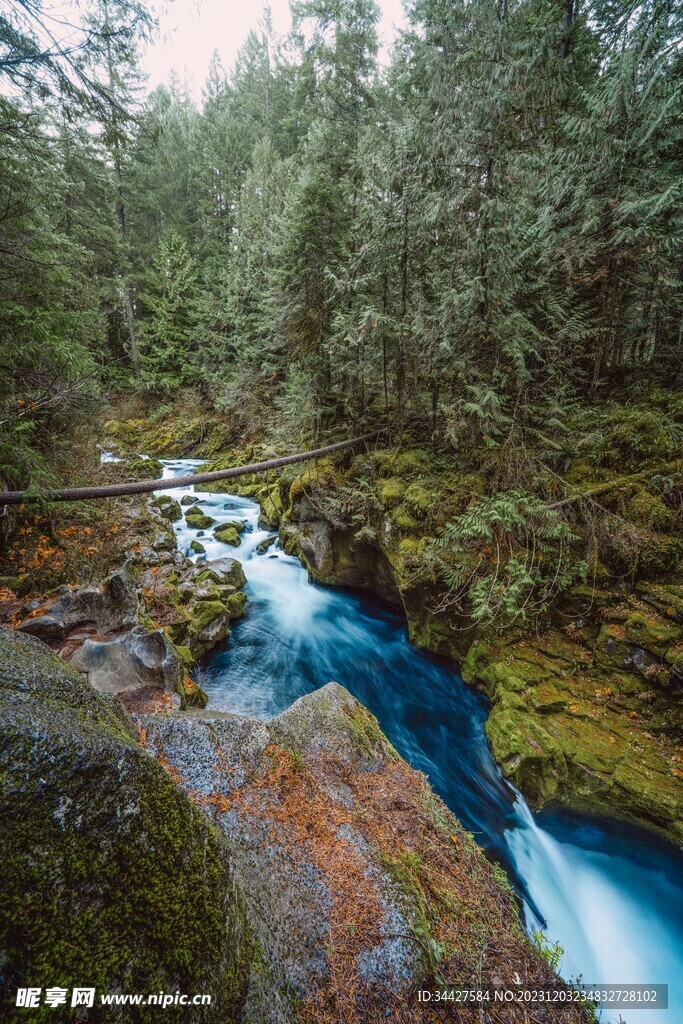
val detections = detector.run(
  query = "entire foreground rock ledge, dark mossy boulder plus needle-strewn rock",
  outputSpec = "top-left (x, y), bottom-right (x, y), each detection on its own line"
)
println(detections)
top-left (0, 629), bottom-right (584, 1024)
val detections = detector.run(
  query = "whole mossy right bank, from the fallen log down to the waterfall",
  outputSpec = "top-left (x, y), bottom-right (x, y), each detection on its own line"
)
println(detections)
top-left (281, 450), bottom-right (683, 842)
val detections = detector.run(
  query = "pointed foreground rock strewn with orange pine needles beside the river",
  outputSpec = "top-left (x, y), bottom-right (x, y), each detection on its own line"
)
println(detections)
top-left (139, 683), bottom-right (585, 1024)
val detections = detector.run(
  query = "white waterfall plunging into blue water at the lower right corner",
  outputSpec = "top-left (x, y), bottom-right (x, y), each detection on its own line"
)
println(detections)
top-left (505, 794), bottom-right (683, 1024)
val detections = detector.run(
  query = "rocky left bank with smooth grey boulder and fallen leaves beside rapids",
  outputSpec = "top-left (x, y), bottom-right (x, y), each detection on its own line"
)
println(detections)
top-left (18, 552), bottom-right (247, 707)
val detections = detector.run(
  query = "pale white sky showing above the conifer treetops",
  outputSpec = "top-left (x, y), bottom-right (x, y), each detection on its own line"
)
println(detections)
top-left (142, 0), bottom-right (404, 99)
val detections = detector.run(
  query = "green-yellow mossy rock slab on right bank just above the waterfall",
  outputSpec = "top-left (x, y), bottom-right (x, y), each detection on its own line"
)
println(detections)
top-left (462, 609), bottom-right (683, 843)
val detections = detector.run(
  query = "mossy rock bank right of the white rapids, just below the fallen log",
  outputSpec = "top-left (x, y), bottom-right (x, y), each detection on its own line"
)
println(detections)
top-left (280, 449), bottom-right (483, 659)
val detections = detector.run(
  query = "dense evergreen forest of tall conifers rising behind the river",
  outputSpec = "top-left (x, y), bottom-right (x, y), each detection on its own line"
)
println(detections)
top-left (0, 0), bottom-right (683, 487)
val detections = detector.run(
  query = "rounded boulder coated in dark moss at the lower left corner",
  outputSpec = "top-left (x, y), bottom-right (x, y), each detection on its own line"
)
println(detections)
top-left (0, 628), bottom-right (251, 1024)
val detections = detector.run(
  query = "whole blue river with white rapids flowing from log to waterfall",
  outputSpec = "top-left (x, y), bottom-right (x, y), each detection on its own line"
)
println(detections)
top-left (157, 459), bottom-right (683, 1024)
